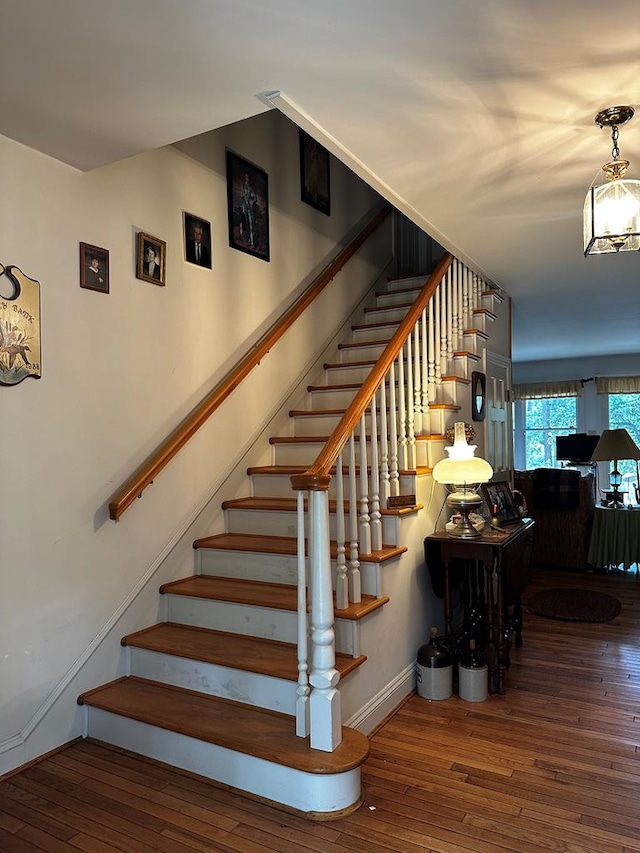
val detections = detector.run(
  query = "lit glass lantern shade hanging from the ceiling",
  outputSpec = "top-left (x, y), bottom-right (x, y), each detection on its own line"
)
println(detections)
top-left (583, 178), bottom-right (640, 255)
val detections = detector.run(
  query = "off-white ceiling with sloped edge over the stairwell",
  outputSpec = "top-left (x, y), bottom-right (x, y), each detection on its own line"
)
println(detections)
top-left (0, 0), bottom-right (640, 361)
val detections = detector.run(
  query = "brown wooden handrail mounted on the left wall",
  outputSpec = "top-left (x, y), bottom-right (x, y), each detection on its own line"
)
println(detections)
top-left (109, 204), bottom-right (392, 521)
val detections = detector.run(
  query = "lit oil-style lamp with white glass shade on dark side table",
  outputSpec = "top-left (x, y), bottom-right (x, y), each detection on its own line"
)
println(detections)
top-left (432, 422), bottom-right (493, 539)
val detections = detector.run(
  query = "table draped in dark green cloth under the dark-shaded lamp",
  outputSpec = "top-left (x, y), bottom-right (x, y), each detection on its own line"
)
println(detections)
top-left (587, 506), bottom-right (640, 569)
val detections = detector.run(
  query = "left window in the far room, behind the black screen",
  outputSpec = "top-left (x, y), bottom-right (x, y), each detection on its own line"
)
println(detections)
top-left (524, 397), bottom-right (577, 469)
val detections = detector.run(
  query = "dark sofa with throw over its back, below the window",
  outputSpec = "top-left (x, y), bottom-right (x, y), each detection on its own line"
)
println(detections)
top-left (514, 468), bottom-right (596, 571)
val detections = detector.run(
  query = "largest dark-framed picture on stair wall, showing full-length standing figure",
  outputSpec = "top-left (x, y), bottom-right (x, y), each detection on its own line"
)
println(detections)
top-left (227, 151), bottom-right (269, 261)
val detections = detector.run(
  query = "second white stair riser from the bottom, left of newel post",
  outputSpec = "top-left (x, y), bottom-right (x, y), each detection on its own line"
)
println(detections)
top-left (131, 646), bottom-right (297, 714)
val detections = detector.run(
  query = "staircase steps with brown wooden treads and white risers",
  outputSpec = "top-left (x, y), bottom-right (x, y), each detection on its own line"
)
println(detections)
top-left (78, 262), bottom-right (495, 819)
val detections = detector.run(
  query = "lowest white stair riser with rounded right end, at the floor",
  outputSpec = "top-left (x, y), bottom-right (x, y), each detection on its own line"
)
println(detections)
top-left (82, 708), bottom-right (361, 815)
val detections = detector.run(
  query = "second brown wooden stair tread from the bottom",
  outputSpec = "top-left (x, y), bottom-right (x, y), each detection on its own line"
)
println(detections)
top-left (122, 622), bottom-right (367, 682)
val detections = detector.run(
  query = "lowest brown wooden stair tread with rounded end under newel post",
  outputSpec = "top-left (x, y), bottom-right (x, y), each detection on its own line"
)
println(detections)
top-left (78, 676), bottom-right (369, 774)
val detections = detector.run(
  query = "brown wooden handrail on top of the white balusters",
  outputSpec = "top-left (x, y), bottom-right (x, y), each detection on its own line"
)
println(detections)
top-left (291, 254), bottom-right (453, 491)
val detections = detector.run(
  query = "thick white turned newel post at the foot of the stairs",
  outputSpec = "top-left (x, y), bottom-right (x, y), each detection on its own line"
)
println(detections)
top-left (309, 491), bottom-right (342, 752)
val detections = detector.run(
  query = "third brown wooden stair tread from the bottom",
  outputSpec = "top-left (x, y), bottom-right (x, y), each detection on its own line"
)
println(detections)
top-left (160, 575), bottom-right (389, 621)
